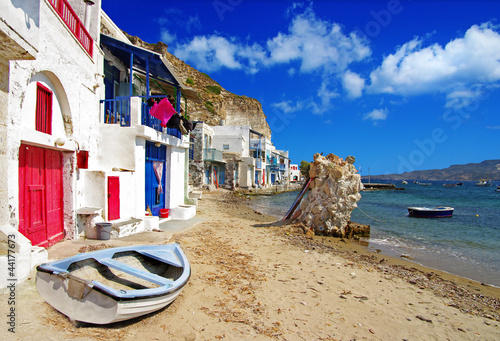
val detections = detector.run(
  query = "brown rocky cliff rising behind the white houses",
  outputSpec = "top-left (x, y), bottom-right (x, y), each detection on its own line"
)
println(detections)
top-left (125, 32), bottom-right (271, 139)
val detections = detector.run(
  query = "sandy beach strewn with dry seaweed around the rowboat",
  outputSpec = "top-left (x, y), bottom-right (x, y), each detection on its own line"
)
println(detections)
top-left (0, 191), bottom-right (500, 341)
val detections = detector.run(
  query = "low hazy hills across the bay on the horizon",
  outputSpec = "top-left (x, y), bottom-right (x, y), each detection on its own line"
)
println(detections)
top-left (363, 160), bottom-right (500, 181)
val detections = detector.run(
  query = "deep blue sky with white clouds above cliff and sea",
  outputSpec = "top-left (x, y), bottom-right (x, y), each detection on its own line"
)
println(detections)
top-left (102, 0), bottom-right (500, 175)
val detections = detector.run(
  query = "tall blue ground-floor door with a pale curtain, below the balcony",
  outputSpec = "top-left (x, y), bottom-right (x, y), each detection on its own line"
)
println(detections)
top-left (145, 141), bottom-right (167, 216)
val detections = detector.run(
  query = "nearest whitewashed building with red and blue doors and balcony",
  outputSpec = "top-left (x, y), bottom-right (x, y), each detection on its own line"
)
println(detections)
top-left (0, 0), bottom-right (198, 288)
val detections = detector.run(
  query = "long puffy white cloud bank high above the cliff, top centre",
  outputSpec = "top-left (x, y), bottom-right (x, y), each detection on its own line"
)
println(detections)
top-left (173, 6), bottom-right (371, 74)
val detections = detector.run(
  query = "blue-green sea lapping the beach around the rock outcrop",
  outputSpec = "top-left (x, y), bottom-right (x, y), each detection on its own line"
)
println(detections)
top-left (251, 179), bottom-right (500, 287)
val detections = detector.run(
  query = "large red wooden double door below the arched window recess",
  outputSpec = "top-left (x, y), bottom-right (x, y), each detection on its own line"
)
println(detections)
top-left (19, 145), bottom-right (64, 247)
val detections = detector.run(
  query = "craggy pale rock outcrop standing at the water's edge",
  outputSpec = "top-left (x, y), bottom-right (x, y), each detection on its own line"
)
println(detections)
top-left (292, 154), bottom-right (369, 237)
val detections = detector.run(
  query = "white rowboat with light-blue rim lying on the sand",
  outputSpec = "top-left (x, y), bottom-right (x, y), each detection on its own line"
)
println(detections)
top-left (36, 243), bottom-right (191, 324)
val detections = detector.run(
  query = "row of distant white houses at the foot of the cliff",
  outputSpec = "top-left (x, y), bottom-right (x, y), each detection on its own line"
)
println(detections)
top-left (189, 121), bottom-right (290, 190)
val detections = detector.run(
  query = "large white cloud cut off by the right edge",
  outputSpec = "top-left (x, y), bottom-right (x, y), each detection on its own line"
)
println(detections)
top-left (368, 24), bottom-right (500, 96)
